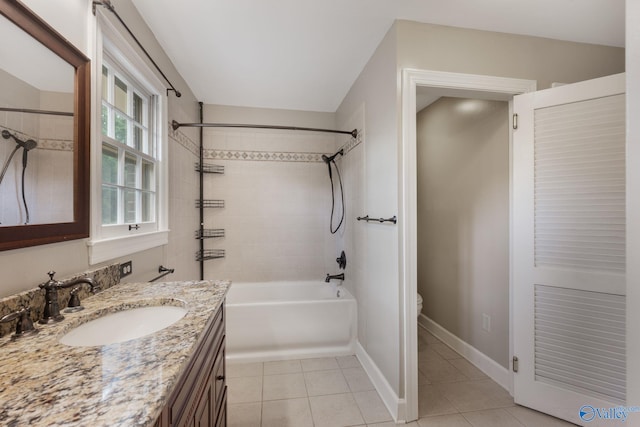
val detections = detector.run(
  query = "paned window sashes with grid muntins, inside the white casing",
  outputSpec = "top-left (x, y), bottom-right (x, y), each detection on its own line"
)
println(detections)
top-left (101, 55), bottom-right (158, 236)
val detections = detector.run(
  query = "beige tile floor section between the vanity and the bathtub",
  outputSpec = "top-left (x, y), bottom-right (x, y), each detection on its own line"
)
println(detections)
top-left (227, 356), bottom-right (392, 427)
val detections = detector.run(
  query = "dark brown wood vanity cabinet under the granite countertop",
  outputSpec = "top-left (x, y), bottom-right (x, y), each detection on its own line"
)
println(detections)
top-left (155, 303), bottom-right (227, 427)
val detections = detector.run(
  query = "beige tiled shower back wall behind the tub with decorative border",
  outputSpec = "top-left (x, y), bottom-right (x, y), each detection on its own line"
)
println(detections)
top-left (204, 106), bottom-right (348, 282)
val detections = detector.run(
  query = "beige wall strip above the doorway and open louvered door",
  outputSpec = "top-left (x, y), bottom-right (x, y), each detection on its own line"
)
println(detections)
top-left (396, 21), bottom-right (625, 89)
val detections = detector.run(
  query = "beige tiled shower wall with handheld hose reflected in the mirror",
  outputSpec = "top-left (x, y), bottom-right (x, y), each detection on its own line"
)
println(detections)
top-left (0, 71), bottom-right (73, 225)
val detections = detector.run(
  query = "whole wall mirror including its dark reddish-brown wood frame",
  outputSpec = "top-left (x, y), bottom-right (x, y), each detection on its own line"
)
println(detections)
top-left (0, 0), bottom-right (91, 250)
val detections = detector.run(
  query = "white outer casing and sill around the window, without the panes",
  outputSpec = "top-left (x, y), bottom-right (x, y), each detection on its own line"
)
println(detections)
top-left (87, 11), bottom-right (169, 264)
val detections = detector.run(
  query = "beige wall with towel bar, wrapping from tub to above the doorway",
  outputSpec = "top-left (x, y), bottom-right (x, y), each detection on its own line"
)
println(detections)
top-left (337, 20), bottom-right (624, 398)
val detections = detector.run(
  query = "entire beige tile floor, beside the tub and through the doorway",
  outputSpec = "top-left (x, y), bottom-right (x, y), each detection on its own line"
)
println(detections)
top-left (227, 328), bottom-right (573, 427)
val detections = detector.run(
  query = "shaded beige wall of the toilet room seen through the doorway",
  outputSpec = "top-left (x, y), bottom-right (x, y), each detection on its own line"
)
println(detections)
top-left (417, 98), bottom-right (509, 368)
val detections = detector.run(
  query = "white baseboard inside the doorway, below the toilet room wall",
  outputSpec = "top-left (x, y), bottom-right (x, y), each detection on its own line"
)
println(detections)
top-left (418, 314), bottom-right (513, 395)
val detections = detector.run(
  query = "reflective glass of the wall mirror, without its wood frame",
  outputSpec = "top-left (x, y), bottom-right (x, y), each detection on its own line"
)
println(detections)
top-left (0, 11), bottom-right (75, 227)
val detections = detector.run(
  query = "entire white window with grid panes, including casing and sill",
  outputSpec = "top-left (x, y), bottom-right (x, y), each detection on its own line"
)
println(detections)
top-left (87, 13), bottom-right (169, 265)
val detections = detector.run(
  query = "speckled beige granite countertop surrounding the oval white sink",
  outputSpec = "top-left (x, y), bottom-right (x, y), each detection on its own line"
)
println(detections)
top-left (0, 281), bottom-right (230, 427)
